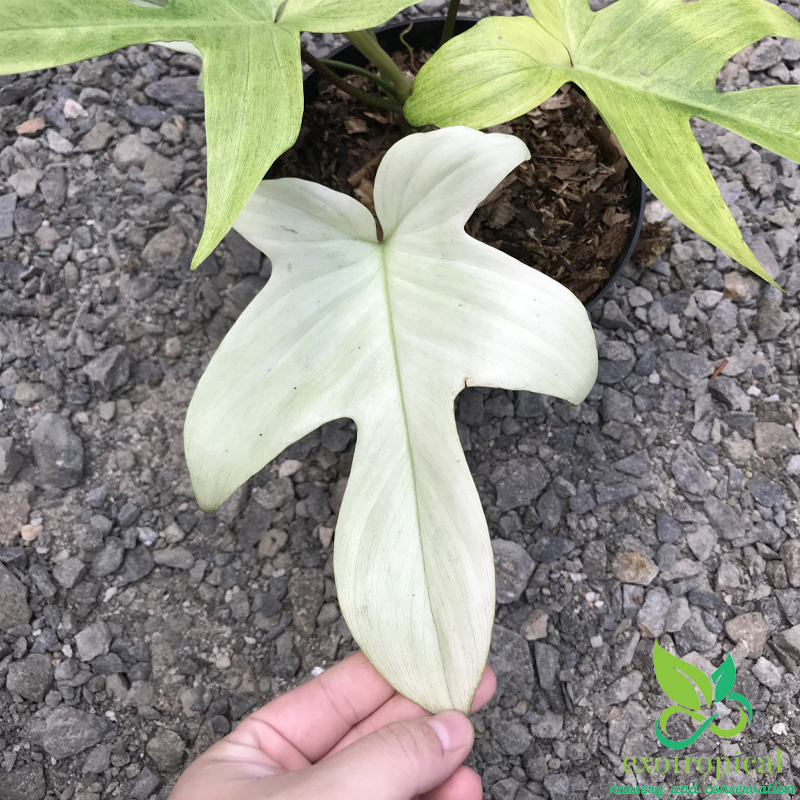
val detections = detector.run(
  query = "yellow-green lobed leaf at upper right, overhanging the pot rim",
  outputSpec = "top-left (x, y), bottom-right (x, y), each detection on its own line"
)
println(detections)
top-left (405, 0), bottom-right (800, 283)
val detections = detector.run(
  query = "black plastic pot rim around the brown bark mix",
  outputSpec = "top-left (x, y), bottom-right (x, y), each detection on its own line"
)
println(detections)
top-left (290, 17), bottom-right (647, 308)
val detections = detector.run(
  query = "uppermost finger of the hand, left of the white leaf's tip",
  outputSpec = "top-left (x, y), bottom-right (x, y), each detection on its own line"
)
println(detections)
top-left (231, 653), bottom-right (396, 769)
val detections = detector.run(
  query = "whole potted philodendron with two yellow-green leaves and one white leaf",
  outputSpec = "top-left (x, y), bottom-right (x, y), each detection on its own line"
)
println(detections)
top-left (0, 0), bottom-right (800, 712)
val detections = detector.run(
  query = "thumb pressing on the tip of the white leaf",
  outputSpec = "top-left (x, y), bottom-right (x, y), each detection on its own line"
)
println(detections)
top-left (309, 711), bottom-right (474, 800)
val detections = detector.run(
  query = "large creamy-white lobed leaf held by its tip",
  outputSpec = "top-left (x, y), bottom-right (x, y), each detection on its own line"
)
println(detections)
top-left (185, 128), bottom-right (597, 712)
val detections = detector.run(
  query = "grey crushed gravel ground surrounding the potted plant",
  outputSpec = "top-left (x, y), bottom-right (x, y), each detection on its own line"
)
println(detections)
top-left (0, 2), bottom-right (800, 800)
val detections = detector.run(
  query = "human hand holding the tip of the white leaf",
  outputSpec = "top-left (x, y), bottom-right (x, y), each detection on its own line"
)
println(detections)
top-left (169, 653), bottom-right (497, 800)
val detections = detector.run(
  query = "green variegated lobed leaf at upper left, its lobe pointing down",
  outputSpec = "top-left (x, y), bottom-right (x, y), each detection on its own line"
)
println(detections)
top-left (0, 0), bottom-right (418, 266)
